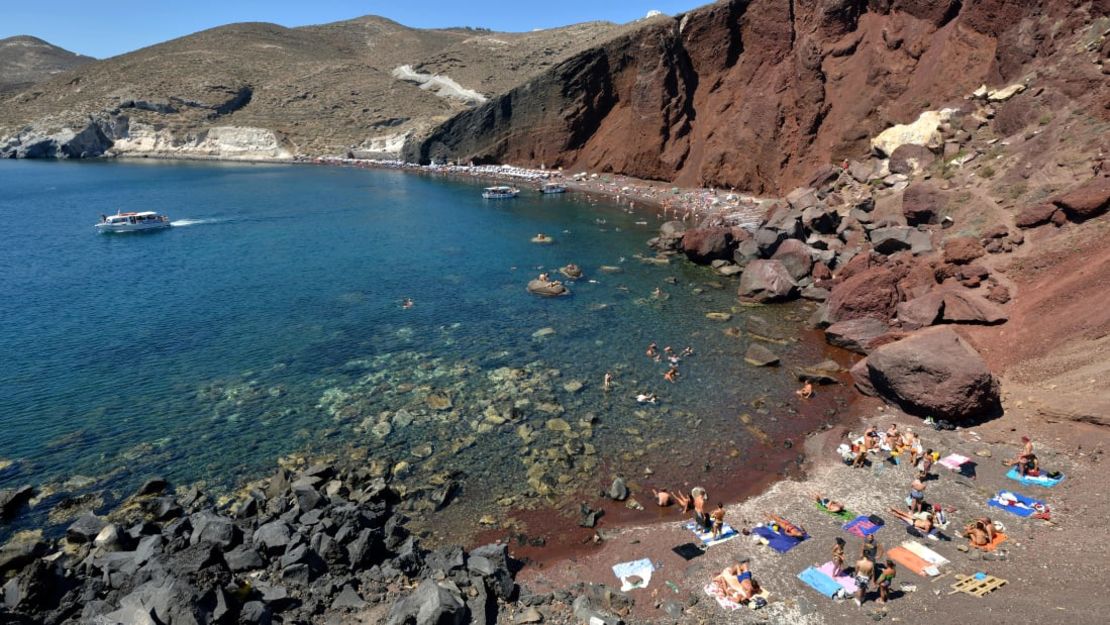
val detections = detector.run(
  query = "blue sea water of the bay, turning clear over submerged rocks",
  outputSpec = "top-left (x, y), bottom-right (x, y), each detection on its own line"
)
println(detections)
top-left (0, 162), bottom-right (821, 537)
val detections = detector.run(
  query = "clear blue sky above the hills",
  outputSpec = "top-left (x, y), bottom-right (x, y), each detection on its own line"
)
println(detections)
top-left (0, 0), bottom-right (710, 59)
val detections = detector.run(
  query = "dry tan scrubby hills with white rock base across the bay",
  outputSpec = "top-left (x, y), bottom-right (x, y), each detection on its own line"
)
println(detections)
top-left (0, 17), bottom-right (622, 158)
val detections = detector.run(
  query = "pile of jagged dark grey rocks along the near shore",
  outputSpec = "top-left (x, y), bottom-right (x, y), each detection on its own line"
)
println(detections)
top-left (0, 455), bottom-right (528, 625)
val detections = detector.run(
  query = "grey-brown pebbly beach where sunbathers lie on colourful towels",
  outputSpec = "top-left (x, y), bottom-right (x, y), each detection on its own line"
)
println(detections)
top-left (497, 392), bottom-right (1110, 624)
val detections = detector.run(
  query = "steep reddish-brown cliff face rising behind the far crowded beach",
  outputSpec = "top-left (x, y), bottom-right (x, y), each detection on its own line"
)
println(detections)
top-left (406, 0), bottom-right (1110, 193)
